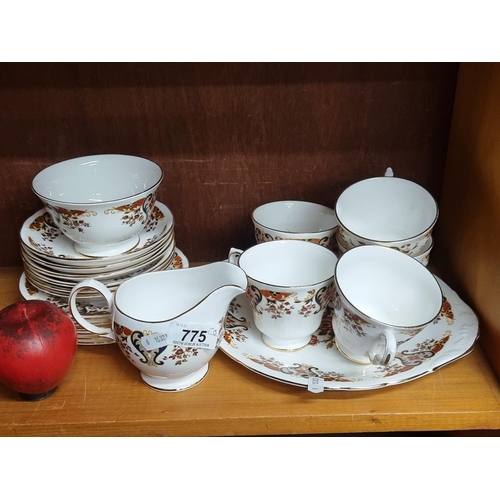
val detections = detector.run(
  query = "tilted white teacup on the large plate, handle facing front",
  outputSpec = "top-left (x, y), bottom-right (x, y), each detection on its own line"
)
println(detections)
top-left (332, 245), bottom-right (443, 365)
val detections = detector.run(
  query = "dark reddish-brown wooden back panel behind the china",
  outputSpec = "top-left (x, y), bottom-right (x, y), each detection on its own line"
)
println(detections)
top-left (0, 63), bottom-right (458, 266)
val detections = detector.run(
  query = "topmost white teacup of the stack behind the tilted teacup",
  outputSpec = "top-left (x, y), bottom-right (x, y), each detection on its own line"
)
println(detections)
top-left (335, 177), bottom-right (439, 257)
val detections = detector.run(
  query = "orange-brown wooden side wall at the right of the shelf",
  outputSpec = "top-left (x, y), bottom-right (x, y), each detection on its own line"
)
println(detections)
top-left (434, 63), bottom-right (500, 376)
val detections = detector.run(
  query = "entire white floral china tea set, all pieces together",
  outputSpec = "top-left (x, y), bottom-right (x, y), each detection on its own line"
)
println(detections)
top-left (16, 155), bottom-right (478, 392)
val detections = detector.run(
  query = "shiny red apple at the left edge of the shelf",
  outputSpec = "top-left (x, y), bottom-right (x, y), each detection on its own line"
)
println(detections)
top-left (0, 300), bottom-right (78, 401)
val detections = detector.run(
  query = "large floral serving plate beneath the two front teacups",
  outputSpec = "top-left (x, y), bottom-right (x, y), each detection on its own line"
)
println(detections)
top-left (220, 278), bottom-right (479, 391)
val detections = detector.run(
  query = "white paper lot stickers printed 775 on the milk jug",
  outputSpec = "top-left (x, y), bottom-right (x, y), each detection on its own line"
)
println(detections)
top-left (141, 321), bottom-right (219, 351)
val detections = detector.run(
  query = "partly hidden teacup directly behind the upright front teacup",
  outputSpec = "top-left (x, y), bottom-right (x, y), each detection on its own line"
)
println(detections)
top-left (252, 200), bottom-right (338, 249)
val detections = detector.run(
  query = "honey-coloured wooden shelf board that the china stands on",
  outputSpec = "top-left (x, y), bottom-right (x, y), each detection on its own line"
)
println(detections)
top-left (0, 267), bottom-right (500, 436)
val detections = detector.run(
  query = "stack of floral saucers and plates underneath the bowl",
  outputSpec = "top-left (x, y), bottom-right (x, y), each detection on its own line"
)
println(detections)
top-left (19, 201), bottom-right (189, 345)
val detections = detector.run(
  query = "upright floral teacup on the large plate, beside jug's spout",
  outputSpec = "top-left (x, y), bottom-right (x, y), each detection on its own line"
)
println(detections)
top-left (229, 240), bottom-right (337, 351)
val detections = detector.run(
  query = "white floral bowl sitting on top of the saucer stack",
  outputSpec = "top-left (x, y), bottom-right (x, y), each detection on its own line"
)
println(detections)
top-left (32, 154), bottom-right (163, 256)
